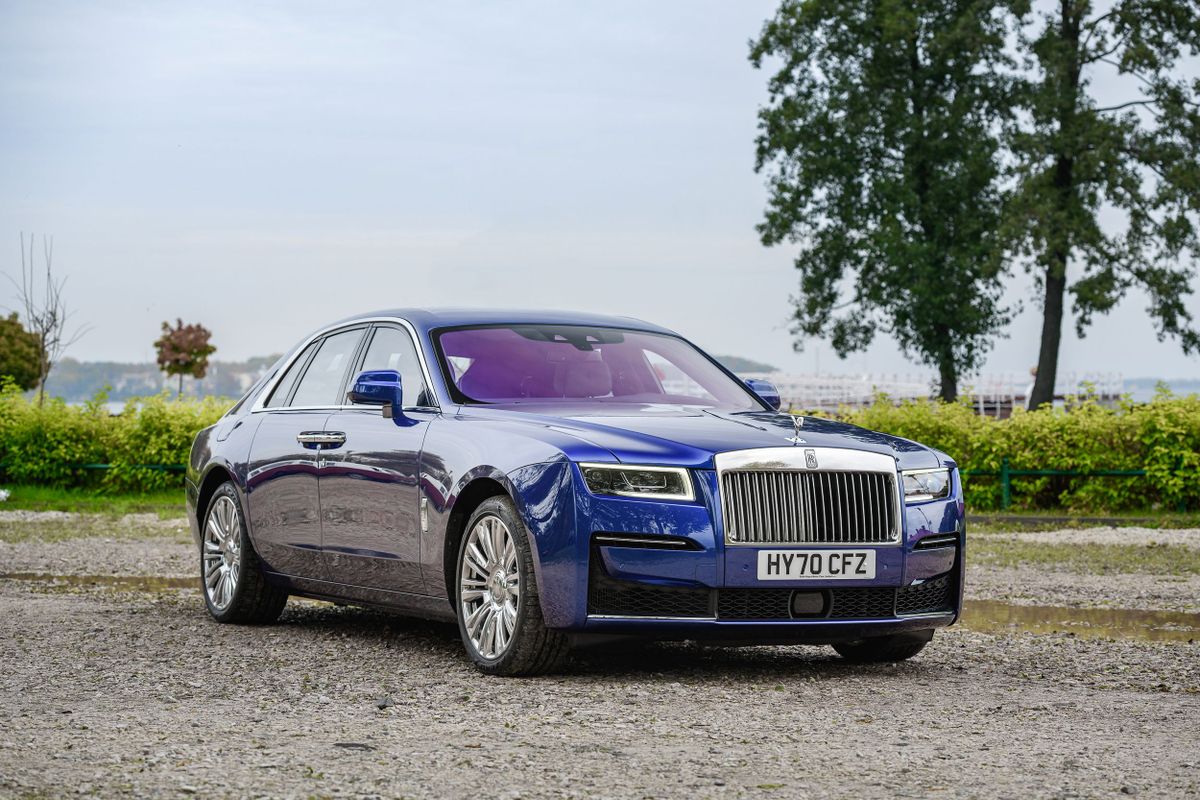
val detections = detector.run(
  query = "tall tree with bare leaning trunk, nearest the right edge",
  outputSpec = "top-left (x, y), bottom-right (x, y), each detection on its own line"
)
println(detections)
top-left (1009, 0), bottom-right (1200, 408)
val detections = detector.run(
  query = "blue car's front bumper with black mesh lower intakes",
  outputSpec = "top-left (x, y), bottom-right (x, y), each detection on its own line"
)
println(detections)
top-left (547, 471), bottom-right (965, 643)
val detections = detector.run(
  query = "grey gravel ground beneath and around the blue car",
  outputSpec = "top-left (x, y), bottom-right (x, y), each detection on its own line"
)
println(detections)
top-left (0, 515), bottom-right (1200, 798)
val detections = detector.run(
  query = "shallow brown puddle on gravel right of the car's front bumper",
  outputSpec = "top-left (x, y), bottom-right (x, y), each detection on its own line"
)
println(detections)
top-left (961, 600), bottom-right (1200, 642)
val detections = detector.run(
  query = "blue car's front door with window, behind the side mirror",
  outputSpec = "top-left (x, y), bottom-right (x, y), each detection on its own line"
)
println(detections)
top-left (320, 324), bottom-right (437, 594)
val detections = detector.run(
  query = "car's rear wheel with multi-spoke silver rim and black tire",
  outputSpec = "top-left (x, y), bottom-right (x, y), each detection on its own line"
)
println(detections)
top-left (200, 481), bottom-right (288, 625)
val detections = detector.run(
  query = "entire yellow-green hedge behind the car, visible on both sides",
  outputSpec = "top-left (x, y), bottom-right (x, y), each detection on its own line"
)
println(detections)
top-left (0, 386), bottom-right (1200, 513)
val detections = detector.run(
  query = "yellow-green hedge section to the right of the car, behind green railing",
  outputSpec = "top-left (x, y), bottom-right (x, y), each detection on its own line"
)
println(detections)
top-left (836, 390), bottom-right (1200, 513)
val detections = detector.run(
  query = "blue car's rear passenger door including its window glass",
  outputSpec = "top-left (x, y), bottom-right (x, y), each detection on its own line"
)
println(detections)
top-left (246, 326), bottom-right (366, 581)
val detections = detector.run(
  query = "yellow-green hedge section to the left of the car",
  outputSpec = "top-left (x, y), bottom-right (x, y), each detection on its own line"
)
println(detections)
top-left (0, 385), bottom-right (230, 492)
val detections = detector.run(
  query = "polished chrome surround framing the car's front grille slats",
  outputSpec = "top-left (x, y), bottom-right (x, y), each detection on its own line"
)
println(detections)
top-left (713, 445), bottom-right (905, 549)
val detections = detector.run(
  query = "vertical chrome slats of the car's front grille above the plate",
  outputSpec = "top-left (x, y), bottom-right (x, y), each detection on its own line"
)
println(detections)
top-left (721, 469), bottom-right (899, 545)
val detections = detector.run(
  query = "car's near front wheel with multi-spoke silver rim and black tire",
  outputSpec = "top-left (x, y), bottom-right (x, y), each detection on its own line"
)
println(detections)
top-left (454, 497), bottom-right (568, 676)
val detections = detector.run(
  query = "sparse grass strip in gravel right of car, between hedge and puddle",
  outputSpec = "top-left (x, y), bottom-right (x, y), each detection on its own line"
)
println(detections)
top-left (967, 536), bottom-right (1200, 576)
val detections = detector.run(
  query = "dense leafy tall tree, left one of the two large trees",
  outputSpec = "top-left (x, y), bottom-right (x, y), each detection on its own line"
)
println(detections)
top-left (750, 0), bottom-right (1010, 399)
